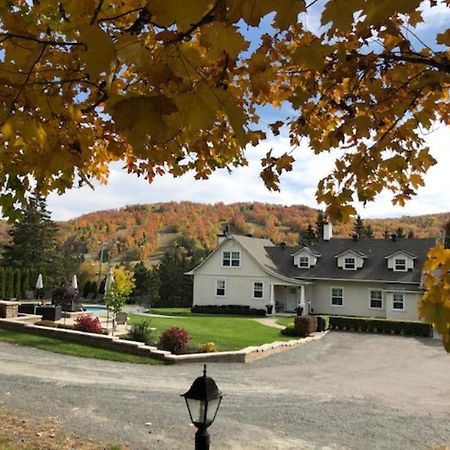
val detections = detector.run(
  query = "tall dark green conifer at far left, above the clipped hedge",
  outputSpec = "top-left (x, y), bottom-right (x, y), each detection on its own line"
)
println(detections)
top-left (3, 196), bottom-right (67, 286)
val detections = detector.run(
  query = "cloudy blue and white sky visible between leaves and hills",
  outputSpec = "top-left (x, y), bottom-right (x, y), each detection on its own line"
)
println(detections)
top-left (48, 2), bottom-right (450, 220)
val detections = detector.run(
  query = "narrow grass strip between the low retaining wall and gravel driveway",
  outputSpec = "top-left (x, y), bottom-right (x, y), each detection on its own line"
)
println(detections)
top-left (0, 329), bottom-right (164, 364)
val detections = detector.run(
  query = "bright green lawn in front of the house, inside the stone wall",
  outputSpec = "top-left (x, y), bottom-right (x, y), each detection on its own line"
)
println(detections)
top-left (129, 314), bottom-right (292, 351)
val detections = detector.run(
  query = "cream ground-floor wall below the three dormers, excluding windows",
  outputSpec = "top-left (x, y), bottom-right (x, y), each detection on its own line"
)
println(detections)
top-left (306, 280), bottom-right (420, 320)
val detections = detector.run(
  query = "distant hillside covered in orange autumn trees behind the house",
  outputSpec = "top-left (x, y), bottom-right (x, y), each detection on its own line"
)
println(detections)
top-left (0, 202), bottom-right (450, 264)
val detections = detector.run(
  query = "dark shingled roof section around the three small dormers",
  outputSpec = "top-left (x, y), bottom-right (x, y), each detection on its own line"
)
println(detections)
top-left (266, 238), bottom-right (435, 284)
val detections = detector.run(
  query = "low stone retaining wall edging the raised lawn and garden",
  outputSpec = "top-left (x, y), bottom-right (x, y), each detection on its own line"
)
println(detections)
top-left (0, 319), bottom-right (327, 363)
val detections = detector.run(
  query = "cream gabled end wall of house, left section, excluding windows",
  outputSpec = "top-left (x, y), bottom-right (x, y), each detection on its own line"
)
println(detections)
top-left (193, 240), bottom-right (296, 309)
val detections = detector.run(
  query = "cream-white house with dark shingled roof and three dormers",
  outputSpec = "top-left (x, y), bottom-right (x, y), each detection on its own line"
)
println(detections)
top-left (188, 225), bottom-right (435, 320)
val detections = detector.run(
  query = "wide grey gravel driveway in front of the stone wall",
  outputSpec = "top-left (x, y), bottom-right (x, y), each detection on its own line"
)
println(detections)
top-left (0, 332), bottom-right (450, 450)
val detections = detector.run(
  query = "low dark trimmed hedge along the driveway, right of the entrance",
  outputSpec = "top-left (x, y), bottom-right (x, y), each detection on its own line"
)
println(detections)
top-left (330, 316), bottom-right (433, 337)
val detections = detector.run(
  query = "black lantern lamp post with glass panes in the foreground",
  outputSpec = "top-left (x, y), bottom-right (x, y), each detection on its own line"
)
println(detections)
top-left (182, 364), bottom-right (223, 450)
